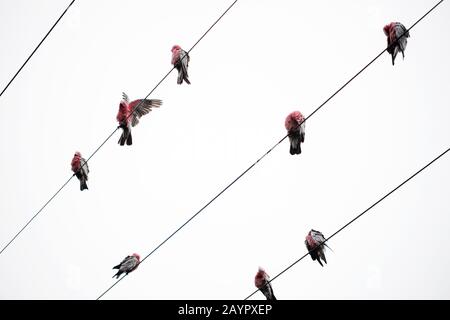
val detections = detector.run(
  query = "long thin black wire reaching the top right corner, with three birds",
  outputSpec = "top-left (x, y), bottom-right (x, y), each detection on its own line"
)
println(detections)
top-left (97, 0), bottom-right (444, 300)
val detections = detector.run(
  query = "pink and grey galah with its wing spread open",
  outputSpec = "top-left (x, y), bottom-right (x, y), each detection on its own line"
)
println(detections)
top-left (117, 93), bottom-right (162, 146)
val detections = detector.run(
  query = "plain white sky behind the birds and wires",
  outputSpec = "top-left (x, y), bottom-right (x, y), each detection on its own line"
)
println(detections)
top-left (0, 0), bottom-right (450, 299)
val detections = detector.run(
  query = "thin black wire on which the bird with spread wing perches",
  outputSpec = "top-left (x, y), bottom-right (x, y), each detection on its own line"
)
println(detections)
top-left (0, 0), bottom-right (238, 255)
